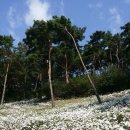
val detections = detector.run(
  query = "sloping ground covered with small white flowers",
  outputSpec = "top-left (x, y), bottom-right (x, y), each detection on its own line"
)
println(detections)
top-left (0, 90), bottom-right (130, 130)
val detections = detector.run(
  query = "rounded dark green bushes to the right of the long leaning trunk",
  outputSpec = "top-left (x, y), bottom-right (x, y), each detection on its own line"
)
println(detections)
top-left (96, 65), bottom-right (130, 94)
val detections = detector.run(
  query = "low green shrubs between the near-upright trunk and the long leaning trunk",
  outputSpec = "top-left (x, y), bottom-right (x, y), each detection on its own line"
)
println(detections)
top-left (53, 76), bottom-right (94, 98)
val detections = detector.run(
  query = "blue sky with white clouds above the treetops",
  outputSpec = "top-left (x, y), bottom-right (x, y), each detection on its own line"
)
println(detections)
top-left (0, 0), bottom-right (130, 45)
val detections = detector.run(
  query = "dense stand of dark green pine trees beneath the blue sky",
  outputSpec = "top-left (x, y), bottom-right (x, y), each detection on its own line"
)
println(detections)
top-left (0, 16), bottom-right (130, 103)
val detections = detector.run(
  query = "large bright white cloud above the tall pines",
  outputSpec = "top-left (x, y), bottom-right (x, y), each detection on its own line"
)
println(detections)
top-left (25, 0), bottom-right (51, 26)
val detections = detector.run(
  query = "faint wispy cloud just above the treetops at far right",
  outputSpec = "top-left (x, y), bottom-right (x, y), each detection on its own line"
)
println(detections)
top-left (108, 8), bottom-right (123, 34)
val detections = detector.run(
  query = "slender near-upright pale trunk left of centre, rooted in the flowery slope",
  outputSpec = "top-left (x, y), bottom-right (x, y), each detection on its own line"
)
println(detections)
top-left (48, 47), bottom-right (55, 108)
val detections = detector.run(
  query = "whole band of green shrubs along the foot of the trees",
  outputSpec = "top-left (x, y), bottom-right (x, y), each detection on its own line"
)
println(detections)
top-left (3, 65), bottom-right (130, 102)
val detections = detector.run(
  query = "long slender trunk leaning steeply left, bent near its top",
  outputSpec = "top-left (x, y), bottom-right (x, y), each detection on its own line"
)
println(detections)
top-left (65, 27), bottom-right (102, 104)
